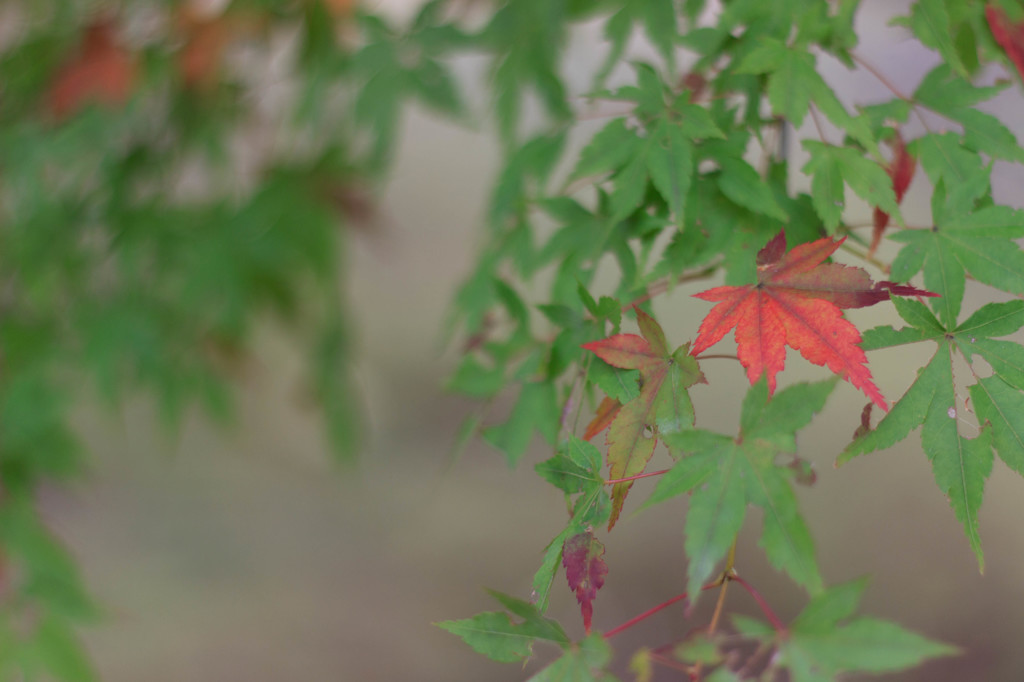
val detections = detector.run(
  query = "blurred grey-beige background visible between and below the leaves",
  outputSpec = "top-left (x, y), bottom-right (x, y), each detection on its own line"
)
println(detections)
top-left (4, 0), bottom-right (1024, 682)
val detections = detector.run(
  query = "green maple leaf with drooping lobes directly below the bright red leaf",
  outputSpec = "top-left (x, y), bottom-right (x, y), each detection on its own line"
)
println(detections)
top-left (647, 380), bottom-right (836, 595)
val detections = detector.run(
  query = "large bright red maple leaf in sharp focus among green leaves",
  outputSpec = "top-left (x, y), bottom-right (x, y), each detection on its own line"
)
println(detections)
top-left (690, 231), bottom-right (937, 410)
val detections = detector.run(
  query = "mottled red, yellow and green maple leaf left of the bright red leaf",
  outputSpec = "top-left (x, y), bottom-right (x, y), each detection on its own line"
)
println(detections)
top-left (583, 308), bottom-right (703, 529)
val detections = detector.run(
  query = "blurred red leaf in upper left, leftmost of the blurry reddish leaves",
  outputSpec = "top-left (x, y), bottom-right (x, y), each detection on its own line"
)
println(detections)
top-left (48, 20), bottom-right (138, 119)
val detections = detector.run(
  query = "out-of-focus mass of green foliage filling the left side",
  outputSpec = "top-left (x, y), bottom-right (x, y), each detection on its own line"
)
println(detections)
top-left (0, 0), bottom-right (407, 682)
